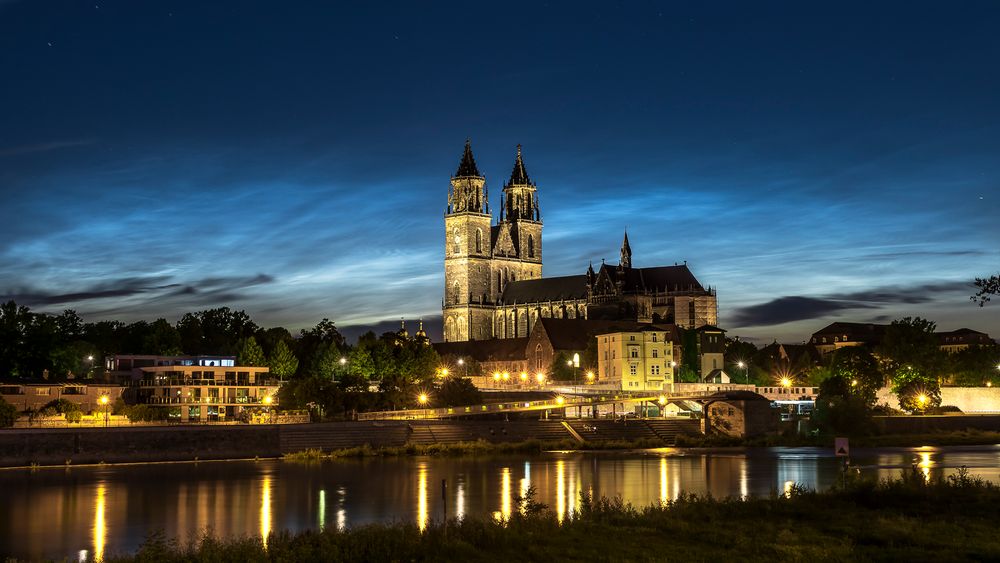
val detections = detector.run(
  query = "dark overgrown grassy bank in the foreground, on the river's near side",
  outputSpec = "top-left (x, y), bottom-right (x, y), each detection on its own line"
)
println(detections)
top-left (99, 473), bottom-right (1000, 562)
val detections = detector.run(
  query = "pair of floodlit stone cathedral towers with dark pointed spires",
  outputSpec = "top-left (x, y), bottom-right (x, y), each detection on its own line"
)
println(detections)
top-left (442, 141), bottom-right (542, 342)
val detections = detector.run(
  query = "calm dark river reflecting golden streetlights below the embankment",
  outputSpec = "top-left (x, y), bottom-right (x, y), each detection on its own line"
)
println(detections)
top-left (0, 446), bottom-right (1000, 559)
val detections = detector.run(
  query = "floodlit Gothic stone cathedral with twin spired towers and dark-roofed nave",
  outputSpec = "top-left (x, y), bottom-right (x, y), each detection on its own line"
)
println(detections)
top-left (442, 141), bottom-right (718, 342)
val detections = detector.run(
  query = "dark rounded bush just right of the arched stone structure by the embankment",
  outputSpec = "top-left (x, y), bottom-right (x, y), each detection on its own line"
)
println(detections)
top-left (812, 375), bottom-right (874, 436)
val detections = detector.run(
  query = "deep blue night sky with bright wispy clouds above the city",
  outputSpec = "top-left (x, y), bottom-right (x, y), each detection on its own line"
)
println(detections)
top-left (0, 0), bottom-right (1000, 342)
